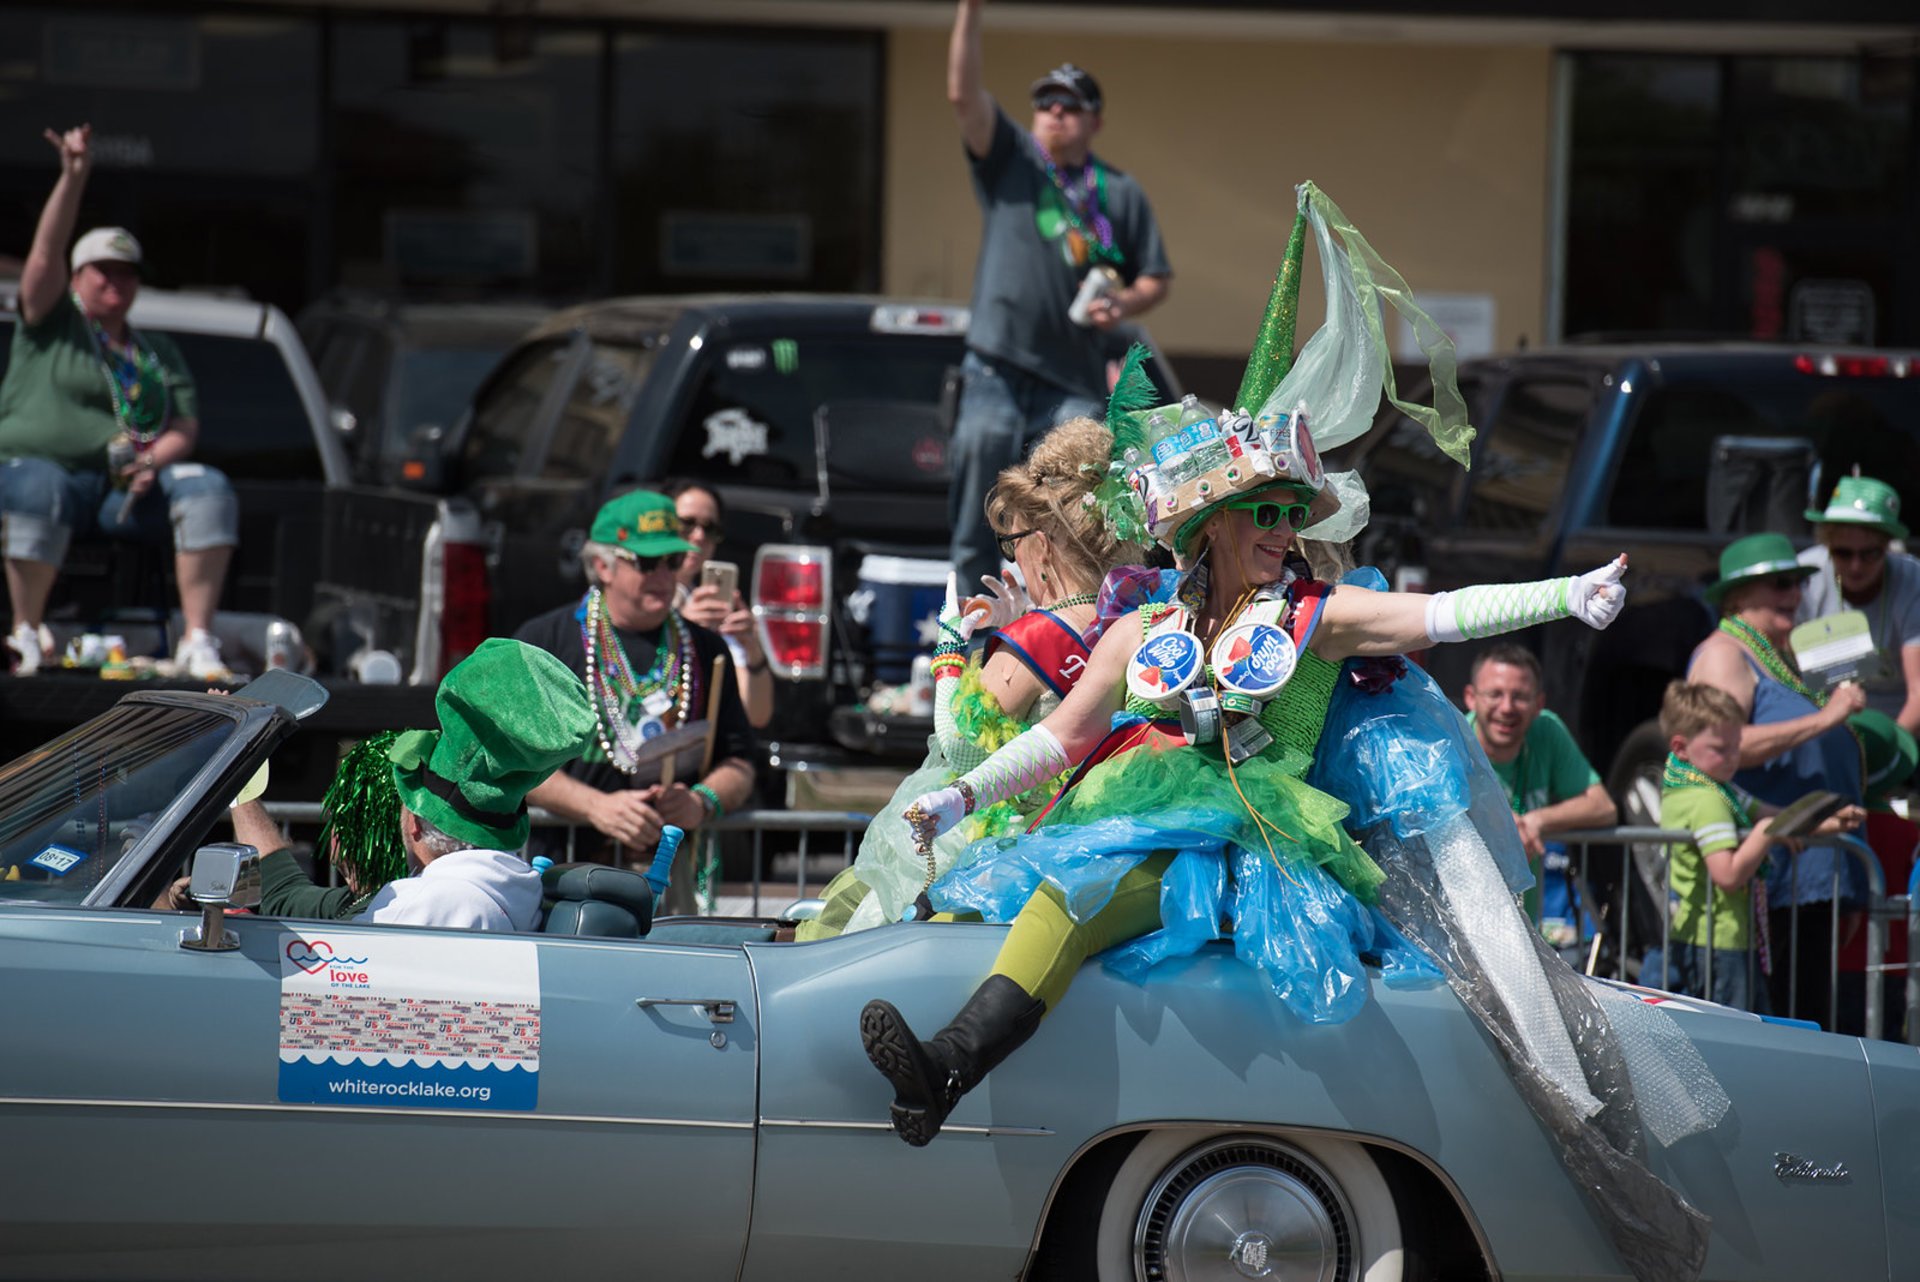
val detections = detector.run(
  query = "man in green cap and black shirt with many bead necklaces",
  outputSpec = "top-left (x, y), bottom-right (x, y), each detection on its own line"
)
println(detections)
top-left (515, 489), bottom-right (758, 890)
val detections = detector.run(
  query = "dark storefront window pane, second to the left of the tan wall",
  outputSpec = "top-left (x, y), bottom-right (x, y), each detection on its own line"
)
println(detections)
top-left (330, 17), bottom-right (601, 294)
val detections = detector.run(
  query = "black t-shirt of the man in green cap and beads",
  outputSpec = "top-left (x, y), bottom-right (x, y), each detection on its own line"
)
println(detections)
top-left (513, 601), bottom-right (760, 793)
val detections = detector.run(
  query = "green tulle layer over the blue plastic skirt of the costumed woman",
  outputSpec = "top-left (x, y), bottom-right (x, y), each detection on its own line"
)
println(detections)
top-left (1046, 741), bottom-right (1386, 904)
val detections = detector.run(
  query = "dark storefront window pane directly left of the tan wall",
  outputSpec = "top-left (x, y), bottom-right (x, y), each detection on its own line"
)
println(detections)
top-left (612, 31), bottom-right (881, 294)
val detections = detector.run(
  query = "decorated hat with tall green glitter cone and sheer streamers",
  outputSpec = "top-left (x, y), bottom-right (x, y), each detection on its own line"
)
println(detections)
top-left (1094, 182), bottom-right (1473, 555)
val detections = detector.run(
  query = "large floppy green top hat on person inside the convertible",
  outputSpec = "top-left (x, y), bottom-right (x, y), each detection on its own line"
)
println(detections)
top-left (386, 637), bottom-right (593, 850)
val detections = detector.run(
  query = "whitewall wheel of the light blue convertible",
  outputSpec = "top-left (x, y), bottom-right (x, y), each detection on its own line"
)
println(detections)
top-left (1094, 1130), bottom-right (1402, 1282)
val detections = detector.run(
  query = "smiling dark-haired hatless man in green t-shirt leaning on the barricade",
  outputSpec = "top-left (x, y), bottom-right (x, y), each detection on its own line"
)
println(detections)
top-left (1465, 641), bottom-right (1619, 942)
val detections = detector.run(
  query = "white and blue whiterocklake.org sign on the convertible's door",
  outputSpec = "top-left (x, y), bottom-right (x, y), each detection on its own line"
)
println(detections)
top-left (280, 931), bottom-right (540, 1111)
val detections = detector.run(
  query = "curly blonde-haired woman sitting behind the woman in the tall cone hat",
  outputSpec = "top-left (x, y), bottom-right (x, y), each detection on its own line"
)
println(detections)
top-left (797, 418), bottom-right (1158, 940)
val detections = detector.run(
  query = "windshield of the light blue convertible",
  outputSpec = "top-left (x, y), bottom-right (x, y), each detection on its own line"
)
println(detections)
top-left (0, 702), bottom-right (238, 904)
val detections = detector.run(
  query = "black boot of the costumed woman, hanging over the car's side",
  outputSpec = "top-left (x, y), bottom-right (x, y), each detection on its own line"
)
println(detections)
top-left (860, 975), bottom-right (1046, 1148)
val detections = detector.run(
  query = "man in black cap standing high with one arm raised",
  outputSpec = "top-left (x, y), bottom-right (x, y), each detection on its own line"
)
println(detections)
top-left (947, 0), bottom-right (1173, 595)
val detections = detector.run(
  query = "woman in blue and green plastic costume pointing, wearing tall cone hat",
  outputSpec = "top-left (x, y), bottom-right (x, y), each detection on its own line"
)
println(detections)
top-left (860, 184), bottom-right (1726, 1280)
